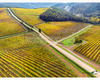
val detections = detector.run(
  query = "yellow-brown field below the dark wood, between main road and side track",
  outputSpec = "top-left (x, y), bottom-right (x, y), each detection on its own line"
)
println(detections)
top-left (36, 21), bottom-right (88, 41)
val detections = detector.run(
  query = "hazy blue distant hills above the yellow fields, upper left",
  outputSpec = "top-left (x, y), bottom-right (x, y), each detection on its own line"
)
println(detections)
top-left (0, 3), bottom-right (56, 9)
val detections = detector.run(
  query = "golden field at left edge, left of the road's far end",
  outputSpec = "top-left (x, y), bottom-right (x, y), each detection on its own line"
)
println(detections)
top-left (0, 8), bottom-right (24, 37)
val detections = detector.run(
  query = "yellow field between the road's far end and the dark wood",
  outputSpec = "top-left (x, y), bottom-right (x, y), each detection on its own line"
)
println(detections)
top-left (12, 8), bottom-right (48, 26)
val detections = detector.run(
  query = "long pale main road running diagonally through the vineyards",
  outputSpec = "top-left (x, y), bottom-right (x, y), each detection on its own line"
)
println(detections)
top-left (8, 8), bottom-right (100, 77)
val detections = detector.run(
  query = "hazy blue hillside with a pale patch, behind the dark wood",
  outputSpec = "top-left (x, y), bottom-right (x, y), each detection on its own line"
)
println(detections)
top-left (54, 3), bottom-right (100, 17)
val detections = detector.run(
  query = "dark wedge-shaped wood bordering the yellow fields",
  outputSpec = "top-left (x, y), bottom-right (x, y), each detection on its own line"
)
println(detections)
top-left (39, 7), bottom-right (100, 23)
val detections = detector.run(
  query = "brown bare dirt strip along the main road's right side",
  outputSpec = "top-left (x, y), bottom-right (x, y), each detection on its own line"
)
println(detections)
top-left (59, 41), bottom-right (100, 69)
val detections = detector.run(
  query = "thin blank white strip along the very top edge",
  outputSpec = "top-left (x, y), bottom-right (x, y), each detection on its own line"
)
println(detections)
top-left (0, 0), bottom-right (100, 3)
